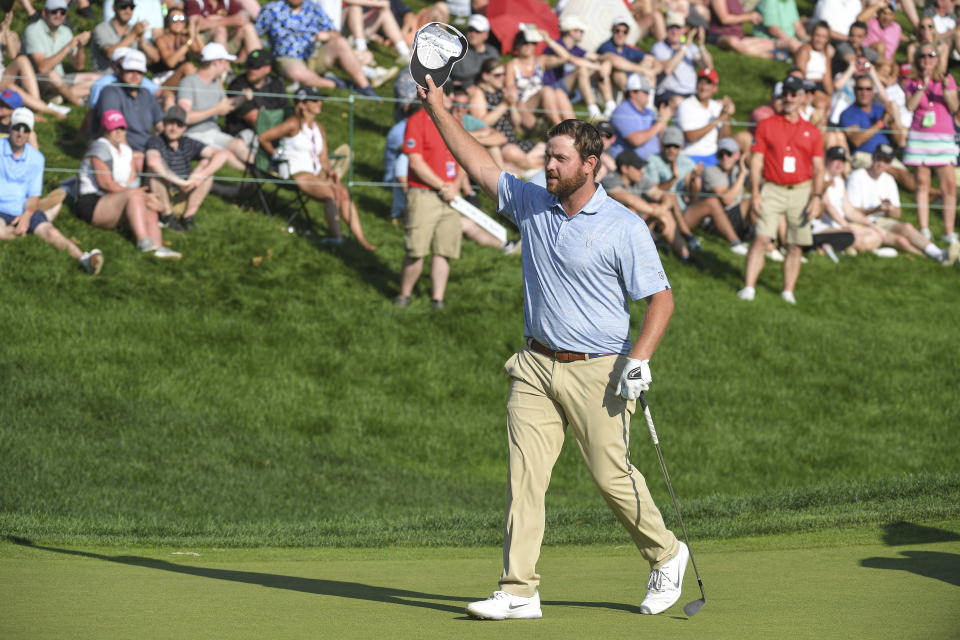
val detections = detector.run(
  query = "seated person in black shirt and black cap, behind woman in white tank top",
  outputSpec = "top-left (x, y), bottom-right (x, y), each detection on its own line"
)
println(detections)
top-left (225, 49), bottom-right (290, 149)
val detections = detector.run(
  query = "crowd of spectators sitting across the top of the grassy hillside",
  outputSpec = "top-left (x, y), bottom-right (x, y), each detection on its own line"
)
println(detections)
top-left (0, 0), bottom-right (960, 296)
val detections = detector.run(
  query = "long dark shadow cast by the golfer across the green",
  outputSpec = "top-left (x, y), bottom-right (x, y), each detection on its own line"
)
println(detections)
top-left (3, 535), bottom-right (652, 620)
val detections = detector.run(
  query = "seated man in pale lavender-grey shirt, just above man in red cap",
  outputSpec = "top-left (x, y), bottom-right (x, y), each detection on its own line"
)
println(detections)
top-left (650, 12), bottom-right (713, 106)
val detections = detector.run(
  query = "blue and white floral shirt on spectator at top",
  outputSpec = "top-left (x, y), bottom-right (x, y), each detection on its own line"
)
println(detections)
top-left (257, 0), bottom-right (337, 60)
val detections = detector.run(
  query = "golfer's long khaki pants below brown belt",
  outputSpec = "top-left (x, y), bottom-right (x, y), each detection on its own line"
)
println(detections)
top-left (500, 348), bottom-right (679, 597)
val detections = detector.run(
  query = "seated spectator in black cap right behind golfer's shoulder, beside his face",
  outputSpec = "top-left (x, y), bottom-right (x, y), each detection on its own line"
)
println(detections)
top-left (603, 149), bottom-right (690, 261)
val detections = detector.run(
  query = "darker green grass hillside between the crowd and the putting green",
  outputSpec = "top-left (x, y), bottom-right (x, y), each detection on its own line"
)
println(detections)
top-left (0, 2), bottom-right (960, 546)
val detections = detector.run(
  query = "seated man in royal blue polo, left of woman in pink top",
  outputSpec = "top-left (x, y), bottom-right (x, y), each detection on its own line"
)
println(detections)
top-left (840, 73), bottom-right (907, 171)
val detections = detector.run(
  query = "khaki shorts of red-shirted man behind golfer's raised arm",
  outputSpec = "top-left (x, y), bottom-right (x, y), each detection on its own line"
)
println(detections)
top-left (403, 188), bottom-right (463, 260)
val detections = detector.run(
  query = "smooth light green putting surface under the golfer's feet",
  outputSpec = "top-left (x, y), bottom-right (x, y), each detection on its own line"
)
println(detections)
top-left (0, 522), bottom-right (960, 640)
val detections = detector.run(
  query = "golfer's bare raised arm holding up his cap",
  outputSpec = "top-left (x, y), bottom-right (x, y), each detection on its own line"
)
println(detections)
top-left (417, 75), bottom-right (500, 202)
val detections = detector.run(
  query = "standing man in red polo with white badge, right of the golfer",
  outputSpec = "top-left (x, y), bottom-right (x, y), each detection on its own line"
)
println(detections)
top-left (737, 76), bottom-right (824, 304)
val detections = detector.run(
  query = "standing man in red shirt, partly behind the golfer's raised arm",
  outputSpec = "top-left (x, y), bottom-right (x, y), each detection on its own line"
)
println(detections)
top-left (394, 90), bottom-right (462, 309)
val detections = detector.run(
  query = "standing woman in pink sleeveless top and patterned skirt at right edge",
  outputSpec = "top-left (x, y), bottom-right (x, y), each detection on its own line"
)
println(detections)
top-left (903, 44), bottom-right (960, 244)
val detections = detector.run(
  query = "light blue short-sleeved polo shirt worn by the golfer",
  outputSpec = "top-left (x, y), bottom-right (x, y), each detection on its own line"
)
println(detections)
top-left (497, 172), bottom-right (670, 353)
